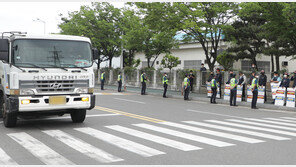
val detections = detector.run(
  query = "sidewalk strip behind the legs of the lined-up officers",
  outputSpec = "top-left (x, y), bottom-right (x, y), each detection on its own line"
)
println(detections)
top-left (96, 85), bottom-right (296, 111)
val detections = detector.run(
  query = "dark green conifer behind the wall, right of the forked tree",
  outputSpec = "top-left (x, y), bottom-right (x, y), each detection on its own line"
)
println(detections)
top-left (225, 3), bottom-right (266, 70)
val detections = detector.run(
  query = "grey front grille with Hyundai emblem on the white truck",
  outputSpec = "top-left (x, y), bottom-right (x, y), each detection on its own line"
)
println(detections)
top-left (20, 80), bottom-right (88, 93)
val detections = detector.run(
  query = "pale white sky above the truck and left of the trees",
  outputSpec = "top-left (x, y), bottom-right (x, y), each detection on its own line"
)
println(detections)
top-left (0, 2), bottom-right (124, 67)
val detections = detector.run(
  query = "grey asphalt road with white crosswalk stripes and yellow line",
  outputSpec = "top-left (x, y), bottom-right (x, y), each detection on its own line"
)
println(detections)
top-left (0, 91), bottom-right (296, 165)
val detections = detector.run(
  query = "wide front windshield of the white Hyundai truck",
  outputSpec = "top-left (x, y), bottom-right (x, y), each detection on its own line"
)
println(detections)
top-left (12, 39), bottom-right (92, 68)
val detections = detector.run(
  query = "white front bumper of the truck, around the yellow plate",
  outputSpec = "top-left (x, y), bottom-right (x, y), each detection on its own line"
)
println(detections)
top-left (18, 94), bottom-right (95, 112)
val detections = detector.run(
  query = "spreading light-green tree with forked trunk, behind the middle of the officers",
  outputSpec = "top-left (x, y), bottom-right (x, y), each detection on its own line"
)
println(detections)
top-left (137, 2), bottom-right (238, 70)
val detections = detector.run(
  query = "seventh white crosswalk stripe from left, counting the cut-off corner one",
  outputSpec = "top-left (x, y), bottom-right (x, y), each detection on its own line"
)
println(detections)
top-left (160, 122), bottom-right (264, 143)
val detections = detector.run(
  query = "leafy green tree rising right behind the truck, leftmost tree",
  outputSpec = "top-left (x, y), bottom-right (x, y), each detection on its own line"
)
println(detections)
top-left (59, 2), bottom-right (122, 68)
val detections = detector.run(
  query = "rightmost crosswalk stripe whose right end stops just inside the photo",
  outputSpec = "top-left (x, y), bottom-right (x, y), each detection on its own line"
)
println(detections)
top-left (183, 121), bottom-right (290, 140)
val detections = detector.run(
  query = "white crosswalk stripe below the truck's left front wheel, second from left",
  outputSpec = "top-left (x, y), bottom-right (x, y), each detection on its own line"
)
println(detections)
top-left (7, 132), bottom-right (74, 165)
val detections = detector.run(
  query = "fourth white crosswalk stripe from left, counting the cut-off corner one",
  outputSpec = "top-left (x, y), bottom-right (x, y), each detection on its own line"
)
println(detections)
top-left (75, 127), bottom-right (165, 157)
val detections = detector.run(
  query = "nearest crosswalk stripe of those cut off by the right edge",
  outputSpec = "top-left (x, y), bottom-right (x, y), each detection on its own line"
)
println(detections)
top-left (205, 120), bottom-right (296, 136)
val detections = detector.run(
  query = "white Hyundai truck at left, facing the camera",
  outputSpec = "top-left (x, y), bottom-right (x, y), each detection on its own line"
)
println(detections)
top-left (0, 32), bottom-right (99, 127)
